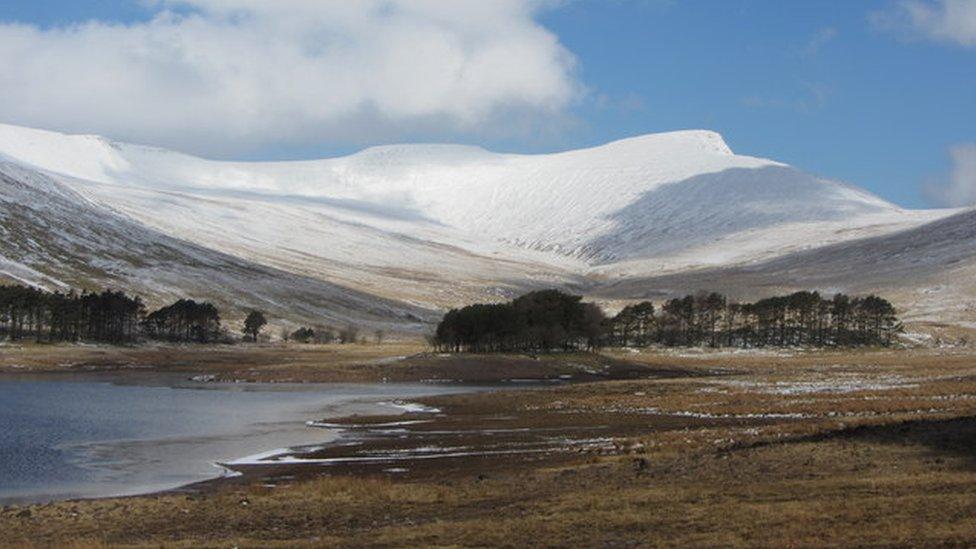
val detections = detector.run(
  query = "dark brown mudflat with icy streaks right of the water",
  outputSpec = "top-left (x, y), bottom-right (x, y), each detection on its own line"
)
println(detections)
top-left (176, 362), bottom-right (708, 493)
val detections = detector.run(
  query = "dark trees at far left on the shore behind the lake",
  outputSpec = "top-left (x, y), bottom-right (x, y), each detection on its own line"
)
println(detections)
top-left (0, 286), bottom-right (267, 343)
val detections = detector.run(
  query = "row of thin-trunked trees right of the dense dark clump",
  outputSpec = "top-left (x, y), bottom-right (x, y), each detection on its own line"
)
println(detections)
top-left (604, 292), bottom-right (902, 347)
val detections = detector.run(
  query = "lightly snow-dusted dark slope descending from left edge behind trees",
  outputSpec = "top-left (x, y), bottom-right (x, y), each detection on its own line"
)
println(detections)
top-left (0, 161), bottom-right (436, 330)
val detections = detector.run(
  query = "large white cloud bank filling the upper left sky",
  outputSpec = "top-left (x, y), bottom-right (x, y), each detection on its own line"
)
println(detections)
top-left (0, 0), bottom-right (581, 154)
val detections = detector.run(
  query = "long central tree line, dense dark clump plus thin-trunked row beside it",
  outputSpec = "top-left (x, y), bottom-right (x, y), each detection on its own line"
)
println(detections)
top-left (431, 290), bottom-right (902, 352)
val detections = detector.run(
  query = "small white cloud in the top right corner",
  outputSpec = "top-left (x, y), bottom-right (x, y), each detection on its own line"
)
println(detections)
top-left (871, 0), bottom-right (976, 47)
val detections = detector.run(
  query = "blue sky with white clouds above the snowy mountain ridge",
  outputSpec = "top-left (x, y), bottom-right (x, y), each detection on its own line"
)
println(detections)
top-left (0, 0), bottom-right (976, 207)
